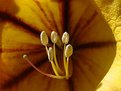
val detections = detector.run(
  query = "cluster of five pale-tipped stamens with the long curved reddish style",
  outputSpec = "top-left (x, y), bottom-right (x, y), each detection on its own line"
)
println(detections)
top-left (23, 31), bottom-right (73, 79)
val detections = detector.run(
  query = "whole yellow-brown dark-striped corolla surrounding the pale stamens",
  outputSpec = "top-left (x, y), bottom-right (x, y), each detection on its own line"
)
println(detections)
top-left (0, 0), bottom-right (116, 91)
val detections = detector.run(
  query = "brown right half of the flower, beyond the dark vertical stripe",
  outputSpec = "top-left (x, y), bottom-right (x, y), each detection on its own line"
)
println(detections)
top-left (69, 0), bottom-right (116, 91)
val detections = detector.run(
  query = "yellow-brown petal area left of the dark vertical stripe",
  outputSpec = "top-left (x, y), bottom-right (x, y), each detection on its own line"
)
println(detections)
top-left (0, 0), bottom-right (69, 91)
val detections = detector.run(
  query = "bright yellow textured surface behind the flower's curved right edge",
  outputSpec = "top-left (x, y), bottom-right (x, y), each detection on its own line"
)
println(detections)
top-left (95, 0), bottom-right (121, 91)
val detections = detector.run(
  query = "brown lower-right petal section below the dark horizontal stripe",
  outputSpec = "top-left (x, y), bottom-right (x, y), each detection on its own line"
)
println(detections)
top-left (72, 44), bottom-right (115, 91)
